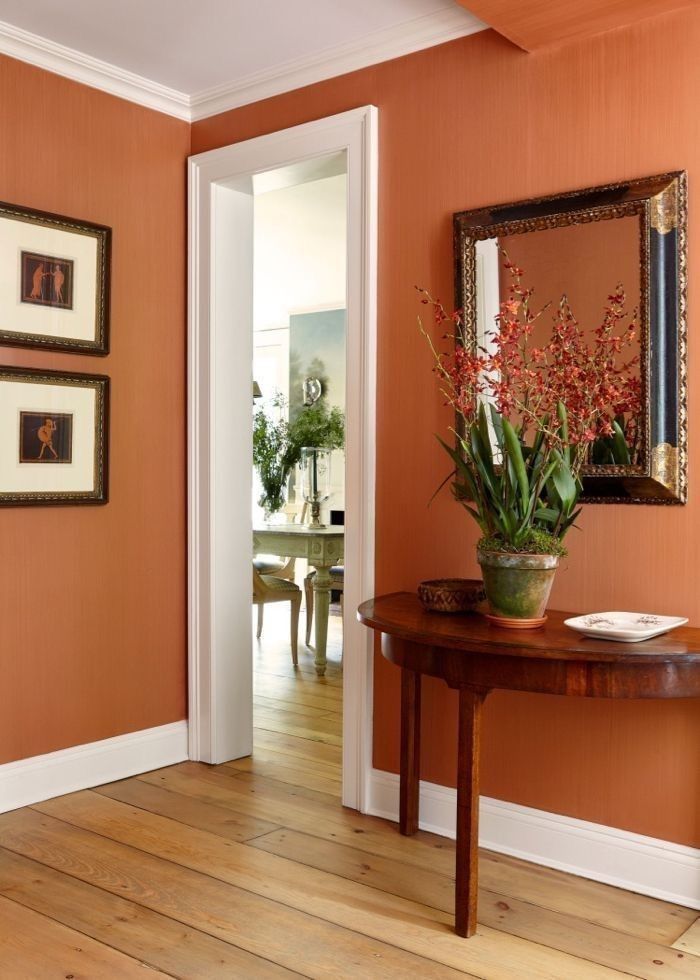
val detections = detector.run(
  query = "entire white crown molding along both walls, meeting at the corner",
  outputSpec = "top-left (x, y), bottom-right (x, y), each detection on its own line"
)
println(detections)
top-left (0, 6), bottom-right (486, 122)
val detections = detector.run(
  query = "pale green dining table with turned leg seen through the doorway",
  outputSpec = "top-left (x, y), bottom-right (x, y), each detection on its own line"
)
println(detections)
top-left (253, 524), bottom-right (345, 677)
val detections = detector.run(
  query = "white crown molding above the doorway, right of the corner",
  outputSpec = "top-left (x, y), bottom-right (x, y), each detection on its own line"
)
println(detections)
top-left (190, 6), bottom-right (486, 122)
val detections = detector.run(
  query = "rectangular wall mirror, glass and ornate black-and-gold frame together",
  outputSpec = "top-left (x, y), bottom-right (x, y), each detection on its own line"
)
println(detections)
top-left (454, 172), bottom-right (687, 504)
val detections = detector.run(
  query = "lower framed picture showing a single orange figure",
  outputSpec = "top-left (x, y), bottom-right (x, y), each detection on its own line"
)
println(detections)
top-left (0, 367), bottom-right (109, 506)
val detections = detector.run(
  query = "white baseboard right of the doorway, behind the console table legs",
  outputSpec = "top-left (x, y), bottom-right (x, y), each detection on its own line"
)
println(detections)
top-left (367, 769), bottom-right (700, 909)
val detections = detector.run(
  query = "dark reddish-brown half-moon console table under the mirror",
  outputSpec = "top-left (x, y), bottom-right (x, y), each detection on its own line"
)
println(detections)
top-left (358, 592), bottom-right (700, 937)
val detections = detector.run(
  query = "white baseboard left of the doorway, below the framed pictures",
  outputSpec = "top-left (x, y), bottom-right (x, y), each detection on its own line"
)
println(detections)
top-left (0, 721), bottom-right (188, 813)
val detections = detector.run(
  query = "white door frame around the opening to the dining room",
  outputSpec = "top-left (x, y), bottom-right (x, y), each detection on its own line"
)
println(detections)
top-left (188, 106), bottom-right (378, 810)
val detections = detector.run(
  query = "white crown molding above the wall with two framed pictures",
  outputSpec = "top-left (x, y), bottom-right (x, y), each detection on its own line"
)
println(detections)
top-left (0, 21), bottom-right (190, 122)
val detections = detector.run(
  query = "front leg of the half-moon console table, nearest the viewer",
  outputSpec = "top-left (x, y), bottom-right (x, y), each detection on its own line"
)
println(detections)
top-left (455, 688), bottom-right (488, 938)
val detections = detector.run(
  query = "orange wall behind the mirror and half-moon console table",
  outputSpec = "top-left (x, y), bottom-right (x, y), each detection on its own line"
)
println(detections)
top-left (194, 9), bottom-right (700, 845)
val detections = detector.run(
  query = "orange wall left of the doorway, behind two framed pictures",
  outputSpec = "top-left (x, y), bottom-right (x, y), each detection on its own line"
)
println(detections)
top-left (0, 58), bottom-right (190, 763)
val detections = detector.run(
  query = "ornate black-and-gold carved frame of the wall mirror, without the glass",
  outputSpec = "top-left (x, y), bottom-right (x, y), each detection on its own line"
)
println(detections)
top-left (453, 171), bottom-right (688, 504)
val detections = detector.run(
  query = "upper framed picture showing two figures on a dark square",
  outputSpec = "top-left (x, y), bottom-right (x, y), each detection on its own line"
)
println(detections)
top-left (0, 203), bottom-right (111, 354)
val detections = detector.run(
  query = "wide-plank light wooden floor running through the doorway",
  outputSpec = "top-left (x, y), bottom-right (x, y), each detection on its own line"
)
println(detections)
top-left (0, 607), bottom-right (700, 980)
